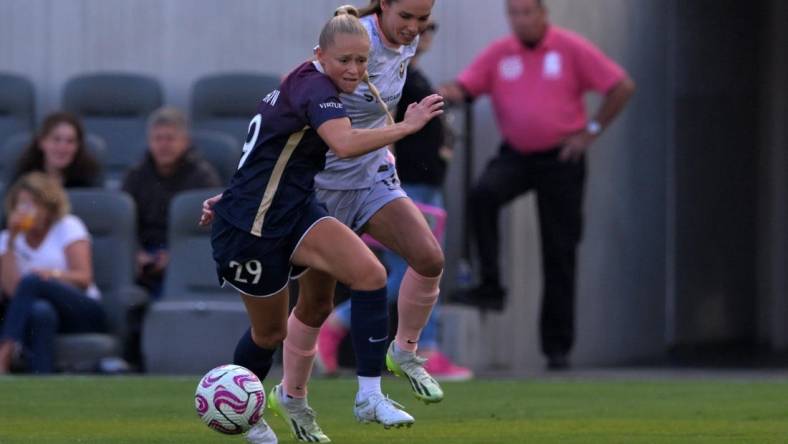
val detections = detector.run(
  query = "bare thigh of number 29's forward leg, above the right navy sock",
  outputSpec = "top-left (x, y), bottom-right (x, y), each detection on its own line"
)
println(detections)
top-left (292, 218), bottom-right (386, 290)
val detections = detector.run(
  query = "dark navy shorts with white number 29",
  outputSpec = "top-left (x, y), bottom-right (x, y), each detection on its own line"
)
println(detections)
top-left (211, 201), bottom-right (330, 298)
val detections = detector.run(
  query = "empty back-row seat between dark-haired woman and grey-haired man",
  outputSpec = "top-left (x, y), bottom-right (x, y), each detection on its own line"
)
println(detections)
top-left (63, 73), bottom-right (162, 188)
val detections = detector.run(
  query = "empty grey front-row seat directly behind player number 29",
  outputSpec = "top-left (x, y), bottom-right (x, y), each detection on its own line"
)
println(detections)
top-left (142, 189), bottom-right (249, 374)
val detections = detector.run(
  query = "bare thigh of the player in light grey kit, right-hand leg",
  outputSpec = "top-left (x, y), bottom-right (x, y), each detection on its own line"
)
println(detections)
top-left (366, 199), bottom-right (444, 276)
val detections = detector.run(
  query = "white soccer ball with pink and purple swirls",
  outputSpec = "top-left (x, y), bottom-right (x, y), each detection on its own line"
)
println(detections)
top-left (194, 365), bottom-right (265, 435)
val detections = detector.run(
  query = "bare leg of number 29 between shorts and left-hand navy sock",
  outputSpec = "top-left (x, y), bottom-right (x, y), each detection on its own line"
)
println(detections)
top-left (241, 288), bottom-right (290, 347)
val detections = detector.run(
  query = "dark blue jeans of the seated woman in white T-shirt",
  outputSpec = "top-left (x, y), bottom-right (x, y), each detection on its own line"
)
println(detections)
top-left (0, 274), bottom-right (105, 373)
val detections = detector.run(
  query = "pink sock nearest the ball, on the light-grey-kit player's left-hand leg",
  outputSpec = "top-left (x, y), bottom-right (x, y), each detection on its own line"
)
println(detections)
top-left (282, 314), bottom-right (320, 398)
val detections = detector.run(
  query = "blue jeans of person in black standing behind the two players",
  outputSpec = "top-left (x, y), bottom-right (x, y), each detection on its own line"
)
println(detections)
top-left (334, 183), bottom-right (443, 349)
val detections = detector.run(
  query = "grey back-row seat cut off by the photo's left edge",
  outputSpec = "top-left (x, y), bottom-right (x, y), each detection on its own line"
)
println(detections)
top-left (0, 73), bottom-right (35, 145)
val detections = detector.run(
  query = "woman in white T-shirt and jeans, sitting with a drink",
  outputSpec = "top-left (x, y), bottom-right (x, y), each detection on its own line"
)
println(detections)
top-left (0, 172), bottom-right (105, 374)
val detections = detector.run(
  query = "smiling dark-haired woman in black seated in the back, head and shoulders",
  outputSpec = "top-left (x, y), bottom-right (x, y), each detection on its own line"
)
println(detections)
top-left (11, 112), bottom-right (102, 188)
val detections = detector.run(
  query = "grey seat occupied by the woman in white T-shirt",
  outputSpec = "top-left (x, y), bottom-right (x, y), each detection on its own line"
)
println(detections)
top-left (55, 189), bottom-right (147, 371)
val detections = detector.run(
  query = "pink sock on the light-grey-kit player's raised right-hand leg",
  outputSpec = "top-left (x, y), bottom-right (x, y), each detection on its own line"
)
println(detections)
top-left (396, 267), bottom-right (443, 352)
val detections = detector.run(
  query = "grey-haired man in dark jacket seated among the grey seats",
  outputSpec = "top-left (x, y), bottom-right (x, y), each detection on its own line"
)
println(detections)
top-left (122, 107), bottom-right (221, 298)
